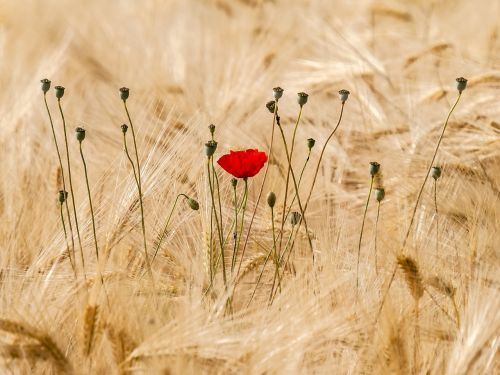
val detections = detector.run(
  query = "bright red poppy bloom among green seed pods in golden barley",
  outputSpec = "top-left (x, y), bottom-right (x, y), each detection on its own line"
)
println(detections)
top-left (217, 150), bottom-right (267, 178)
